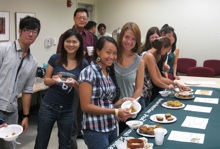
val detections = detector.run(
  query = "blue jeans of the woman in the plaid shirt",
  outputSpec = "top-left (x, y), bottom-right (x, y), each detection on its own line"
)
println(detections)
top-left (83, 129), bottom-right (117, 149)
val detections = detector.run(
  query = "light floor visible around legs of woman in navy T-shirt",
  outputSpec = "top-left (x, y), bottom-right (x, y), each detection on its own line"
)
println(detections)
top-left (17, 113), bottom-right (87, 149)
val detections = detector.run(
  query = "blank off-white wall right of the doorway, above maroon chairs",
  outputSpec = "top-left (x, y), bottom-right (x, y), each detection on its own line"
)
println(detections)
top-left (97, 0), bottom-right (220, 66)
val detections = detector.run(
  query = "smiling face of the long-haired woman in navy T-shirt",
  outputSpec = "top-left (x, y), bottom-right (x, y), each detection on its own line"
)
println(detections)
top-left (64, 36), bottom-right (80, 54)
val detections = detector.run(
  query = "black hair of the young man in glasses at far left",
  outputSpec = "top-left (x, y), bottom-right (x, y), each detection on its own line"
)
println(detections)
top-left (19, 16), bottom-right (41, 34)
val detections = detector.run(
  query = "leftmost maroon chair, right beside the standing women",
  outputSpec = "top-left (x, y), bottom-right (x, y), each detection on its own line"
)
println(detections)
top-left (177, 58), bottom-right (196, 75)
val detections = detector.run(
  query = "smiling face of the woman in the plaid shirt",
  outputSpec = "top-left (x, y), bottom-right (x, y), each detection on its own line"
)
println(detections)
top-left (97, 41), bottom-right (117, 68)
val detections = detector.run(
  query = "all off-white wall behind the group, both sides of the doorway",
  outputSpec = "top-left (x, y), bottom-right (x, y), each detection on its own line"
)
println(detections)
top-left (0, 0), bottom-right (220, 66)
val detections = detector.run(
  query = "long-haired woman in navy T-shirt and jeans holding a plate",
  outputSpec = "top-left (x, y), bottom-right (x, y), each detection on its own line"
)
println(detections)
top-left (35, 29), bottom-right (88, 149)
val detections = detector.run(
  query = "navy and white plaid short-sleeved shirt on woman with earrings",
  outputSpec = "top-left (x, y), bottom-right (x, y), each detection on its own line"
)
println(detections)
top-left (79, 62), bottom-right (116, 132)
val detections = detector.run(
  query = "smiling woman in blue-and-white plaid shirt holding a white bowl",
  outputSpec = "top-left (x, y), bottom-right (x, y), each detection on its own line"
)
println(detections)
top-left (79, 36), bottom-right (133, 149)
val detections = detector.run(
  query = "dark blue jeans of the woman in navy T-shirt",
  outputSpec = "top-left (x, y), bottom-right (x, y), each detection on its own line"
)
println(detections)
top-left (34, 102), bottom-right (74, 149)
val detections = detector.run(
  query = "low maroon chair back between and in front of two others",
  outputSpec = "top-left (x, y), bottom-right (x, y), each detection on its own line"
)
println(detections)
top-left (186, 67), bottom-right (215, 77)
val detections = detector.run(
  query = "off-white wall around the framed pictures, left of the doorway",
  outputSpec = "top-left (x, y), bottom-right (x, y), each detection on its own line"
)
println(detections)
top-left (0, 0), bottom-right (76, 66)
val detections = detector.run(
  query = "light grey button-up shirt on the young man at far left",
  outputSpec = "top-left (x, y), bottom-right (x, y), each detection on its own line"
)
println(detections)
top-left (0, 40), bottom-right (37, 112)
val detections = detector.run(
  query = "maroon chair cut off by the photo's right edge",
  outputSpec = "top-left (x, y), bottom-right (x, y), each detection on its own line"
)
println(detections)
top-left (203, 59), bottom-right (220, 76)
